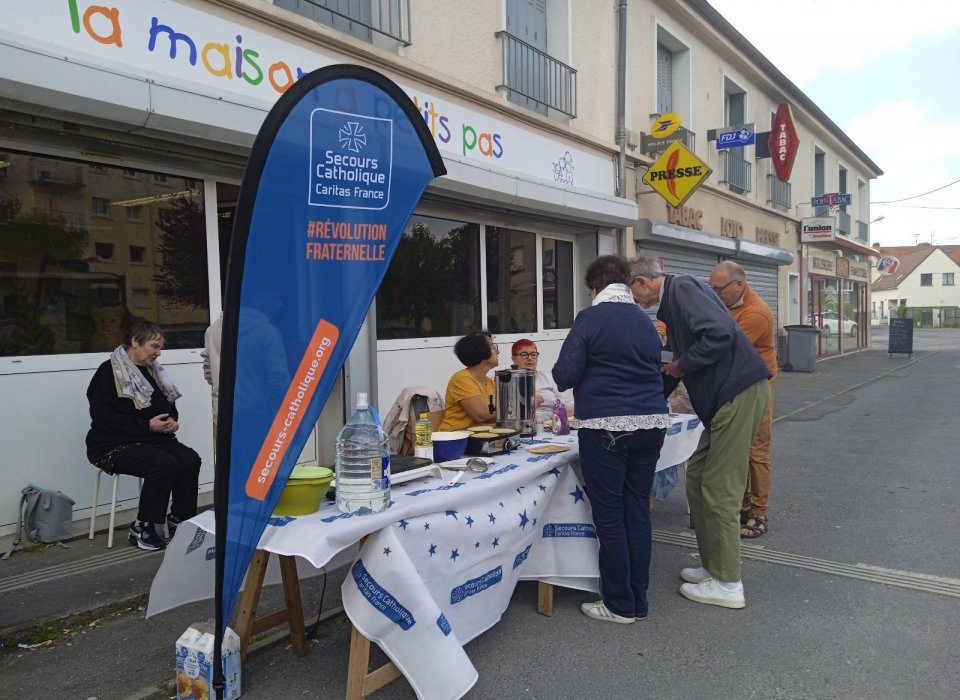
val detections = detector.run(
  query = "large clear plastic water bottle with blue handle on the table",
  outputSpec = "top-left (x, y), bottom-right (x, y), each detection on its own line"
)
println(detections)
top-left (336, 392), bottom-right (390, 515)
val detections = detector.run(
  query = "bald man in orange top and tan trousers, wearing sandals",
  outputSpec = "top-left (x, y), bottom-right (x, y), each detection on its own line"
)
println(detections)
top-left (709, 260), bottom-right (777, 539)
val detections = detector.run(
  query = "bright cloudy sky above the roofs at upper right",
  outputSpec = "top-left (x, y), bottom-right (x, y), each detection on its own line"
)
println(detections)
top-left (708, 0), bottom-right (960, 245)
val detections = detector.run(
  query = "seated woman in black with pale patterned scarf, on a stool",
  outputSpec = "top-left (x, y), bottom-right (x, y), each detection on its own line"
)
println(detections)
top-left (87, 320), bottom-right (200, 550)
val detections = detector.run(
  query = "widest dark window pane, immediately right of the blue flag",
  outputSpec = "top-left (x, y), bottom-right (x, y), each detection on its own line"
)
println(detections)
top-left (377, 215), bottom-right (481, 340)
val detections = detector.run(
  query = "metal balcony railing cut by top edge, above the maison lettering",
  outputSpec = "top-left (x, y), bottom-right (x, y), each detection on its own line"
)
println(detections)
top-left (273, 0), bottom-right (412, 46)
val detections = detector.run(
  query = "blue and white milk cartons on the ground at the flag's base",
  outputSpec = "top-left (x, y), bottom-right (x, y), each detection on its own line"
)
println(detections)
top-left (176, 622), bottom-right (240, 700)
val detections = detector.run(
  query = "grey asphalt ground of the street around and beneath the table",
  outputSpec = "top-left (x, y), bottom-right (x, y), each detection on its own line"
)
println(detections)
top-left (0, 329), bottom-right (960, 700)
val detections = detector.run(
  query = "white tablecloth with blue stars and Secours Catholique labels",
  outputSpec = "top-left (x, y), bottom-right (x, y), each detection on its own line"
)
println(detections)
top-left (147, 416), bottom-right (702, 698)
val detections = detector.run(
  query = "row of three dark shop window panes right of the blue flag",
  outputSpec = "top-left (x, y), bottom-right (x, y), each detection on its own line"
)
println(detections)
top-left (377, 215), bottom-right (575, 340)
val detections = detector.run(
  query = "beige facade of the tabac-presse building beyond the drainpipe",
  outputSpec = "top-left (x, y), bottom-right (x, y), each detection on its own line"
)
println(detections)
top-left (627, 0), bottom-right (881, 355)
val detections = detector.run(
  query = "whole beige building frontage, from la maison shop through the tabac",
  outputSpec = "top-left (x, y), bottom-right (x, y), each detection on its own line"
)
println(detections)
top-left (0, 0), bottom-right (879, 535)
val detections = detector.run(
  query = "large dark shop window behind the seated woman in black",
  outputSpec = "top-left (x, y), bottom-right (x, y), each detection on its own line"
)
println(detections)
top-left (0, 151), bottom-right (210, 356)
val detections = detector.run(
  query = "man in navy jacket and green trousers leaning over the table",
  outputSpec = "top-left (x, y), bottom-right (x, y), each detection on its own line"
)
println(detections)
top-left (630, 256), bottom-right (770, 608)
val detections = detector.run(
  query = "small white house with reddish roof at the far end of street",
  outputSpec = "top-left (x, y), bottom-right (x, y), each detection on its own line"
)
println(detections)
top-left (871, 243), bottom-right (960, 328)
